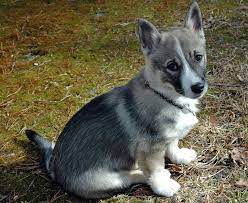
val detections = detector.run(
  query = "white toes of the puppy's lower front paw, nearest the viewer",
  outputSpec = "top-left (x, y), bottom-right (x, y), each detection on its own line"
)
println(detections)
top-left (152, 178), bottom-right (180, 197)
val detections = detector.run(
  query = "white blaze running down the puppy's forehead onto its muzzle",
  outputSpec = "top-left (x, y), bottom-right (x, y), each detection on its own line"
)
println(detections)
top-left (175, 37), bottom-right (202, 97)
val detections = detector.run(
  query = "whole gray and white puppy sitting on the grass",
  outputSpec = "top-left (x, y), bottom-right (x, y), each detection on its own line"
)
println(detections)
top-left (26, 2), bottom-right (208, 198)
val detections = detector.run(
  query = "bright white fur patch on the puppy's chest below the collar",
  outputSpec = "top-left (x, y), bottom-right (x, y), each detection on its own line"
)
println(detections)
top-left (163, 112), bottom-right (198, 139)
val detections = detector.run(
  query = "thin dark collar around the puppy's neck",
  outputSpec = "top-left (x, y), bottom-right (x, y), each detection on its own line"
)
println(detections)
top-left (145, 81), bottom-right (196, 116)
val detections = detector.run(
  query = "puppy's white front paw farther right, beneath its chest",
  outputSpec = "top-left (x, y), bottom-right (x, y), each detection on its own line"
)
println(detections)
top-left (169, 148), bottom-right (197, 165)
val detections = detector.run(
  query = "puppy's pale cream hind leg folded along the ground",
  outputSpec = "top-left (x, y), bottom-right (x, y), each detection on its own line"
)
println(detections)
top-left (70, 170), bottom-right (146, 199)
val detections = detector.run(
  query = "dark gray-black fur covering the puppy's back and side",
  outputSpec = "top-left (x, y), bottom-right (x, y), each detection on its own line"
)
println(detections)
top-left (54, 87), bottom-right (137, 178)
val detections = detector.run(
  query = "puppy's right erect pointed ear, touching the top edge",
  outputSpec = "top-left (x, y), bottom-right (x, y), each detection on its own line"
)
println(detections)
top-left (184, 1), bottom-right (204, 37)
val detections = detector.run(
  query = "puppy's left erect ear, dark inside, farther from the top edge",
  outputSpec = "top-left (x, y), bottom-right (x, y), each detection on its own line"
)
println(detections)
top-left (138, 19), bottom-right (161, 55)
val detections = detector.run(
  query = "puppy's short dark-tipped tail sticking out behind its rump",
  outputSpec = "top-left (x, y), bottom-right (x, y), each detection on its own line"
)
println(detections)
top-left (25, 130), bottom-right (55, 174)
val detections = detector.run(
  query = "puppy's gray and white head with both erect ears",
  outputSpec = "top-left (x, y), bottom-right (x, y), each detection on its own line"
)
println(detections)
top-left (138, 2), bottom-right (208, 99)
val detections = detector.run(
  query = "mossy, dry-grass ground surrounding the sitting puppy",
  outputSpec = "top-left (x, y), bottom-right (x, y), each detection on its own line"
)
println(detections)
top-left (0, 0), bottom-right (248, 203)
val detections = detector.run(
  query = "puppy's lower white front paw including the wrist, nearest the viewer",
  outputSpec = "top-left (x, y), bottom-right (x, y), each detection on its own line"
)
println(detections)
top-left (149, 170), bottom-right (180, 197)
